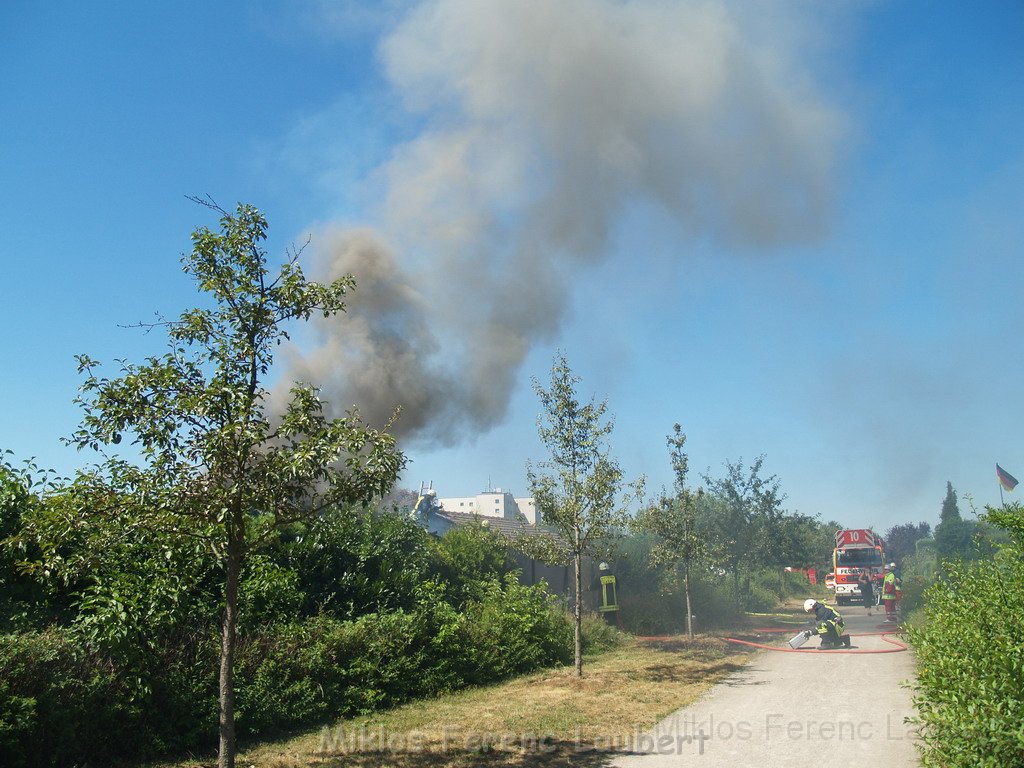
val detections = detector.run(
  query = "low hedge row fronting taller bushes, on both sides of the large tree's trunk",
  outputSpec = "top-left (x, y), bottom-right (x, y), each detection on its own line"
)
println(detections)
top-left (0, 577), bottom-right (571, 768)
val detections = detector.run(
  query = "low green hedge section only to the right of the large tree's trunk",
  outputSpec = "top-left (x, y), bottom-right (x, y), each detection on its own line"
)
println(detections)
top-left (237, 577), bottom-right (571, 733)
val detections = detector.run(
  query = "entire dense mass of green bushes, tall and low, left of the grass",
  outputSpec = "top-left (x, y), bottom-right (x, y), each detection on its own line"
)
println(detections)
top-left (0, 487), bottom-right (571, 768)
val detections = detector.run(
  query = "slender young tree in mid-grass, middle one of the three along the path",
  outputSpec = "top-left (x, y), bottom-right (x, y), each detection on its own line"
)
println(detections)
top-left (526, 353), bottom-right (643, 676)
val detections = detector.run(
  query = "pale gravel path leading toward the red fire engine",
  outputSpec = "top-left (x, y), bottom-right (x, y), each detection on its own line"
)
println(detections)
top-left (610, 607), bottom-right (920, 768)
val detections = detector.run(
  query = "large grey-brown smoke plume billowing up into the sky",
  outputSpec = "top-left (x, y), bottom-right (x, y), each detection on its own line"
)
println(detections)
top-left (285, 0), bottom-right (840, 444)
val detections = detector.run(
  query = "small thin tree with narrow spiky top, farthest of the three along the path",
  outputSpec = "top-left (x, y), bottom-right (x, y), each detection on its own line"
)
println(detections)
top-left (635, 424), bottom-right (710, 637)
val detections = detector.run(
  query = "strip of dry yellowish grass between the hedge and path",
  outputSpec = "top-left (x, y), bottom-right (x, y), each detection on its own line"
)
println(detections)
top-left (165, 636), bottom-right (746, 768)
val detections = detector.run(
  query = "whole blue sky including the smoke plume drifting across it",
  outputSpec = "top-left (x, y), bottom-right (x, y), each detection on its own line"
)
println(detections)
top-left (0, 0), bottom-right (1024, 530)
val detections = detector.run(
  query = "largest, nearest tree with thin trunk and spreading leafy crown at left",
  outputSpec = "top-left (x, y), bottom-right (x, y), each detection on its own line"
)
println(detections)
top-left (36, 200), bottom-right (404, 768)
